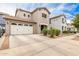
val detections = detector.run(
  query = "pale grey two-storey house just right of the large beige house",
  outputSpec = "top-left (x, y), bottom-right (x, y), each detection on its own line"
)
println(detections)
top-left (49, 14), bottom-right (67, 33)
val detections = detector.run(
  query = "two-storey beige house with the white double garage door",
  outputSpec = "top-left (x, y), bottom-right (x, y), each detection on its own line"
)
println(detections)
top-left (4, 7), bottom-right (50, 34)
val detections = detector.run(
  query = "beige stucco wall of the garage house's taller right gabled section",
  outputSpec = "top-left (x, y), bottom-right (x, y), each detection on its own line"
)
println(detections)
top-left (32, 9), bottom-right (49, 33)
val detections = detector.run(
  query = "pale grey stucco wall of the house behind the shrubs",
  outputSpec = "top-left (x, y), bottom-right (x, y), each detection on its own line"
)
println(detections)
top-left (50, 16), bottom-right (67, 32)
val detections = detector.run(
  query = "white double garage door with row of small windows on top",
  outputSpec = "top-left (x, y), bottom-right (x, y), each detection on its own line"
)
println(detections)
top-left (11, 23), bottom-right (33, 34)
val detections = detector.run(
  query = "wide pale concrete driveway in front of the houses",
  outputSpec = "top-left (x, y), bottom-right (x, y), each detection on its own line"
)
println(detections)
top-left (0, 34), bottom-right (79, 56)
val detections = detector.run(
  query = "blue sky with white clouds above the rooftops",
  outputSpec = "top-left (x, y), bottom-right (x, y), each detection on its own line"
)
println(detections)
top-left (0, 3), bottom-right (79, 22)
